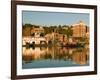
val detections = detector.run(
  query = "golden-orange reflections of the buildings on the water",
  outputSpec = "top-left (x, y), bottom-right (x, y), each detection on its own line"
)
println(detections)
top-left (23, 47), bottom-right (89, 66)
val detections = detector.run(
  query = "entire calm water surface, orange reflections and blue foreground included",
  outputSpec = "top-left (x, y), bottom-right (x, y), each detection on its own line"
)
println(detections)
top-left (22, 47), bottom-right (89, 69)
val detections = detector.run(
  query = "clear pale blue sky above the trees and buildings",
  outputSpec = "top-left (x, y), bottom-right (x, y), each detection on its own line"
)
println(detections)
top-left (22, 11), bottom-right (89, 26)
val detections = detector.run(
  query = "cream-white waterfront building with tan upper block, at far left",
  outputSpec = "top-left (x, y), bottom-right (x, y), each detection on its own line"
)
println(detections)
top-left (23, 26), bottom-right (46, 45)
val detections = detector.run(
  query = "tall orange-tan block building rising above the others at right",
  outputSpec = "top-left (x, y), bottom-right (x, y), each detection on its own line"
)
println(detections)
top-left (72, 21), bottom-right (89, 37)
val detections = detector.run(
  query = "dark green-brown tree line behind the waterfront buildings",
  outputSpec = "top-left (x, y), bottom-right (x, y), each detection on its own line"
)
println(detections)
top-left (22, 24), bottom-right (73, 37)
